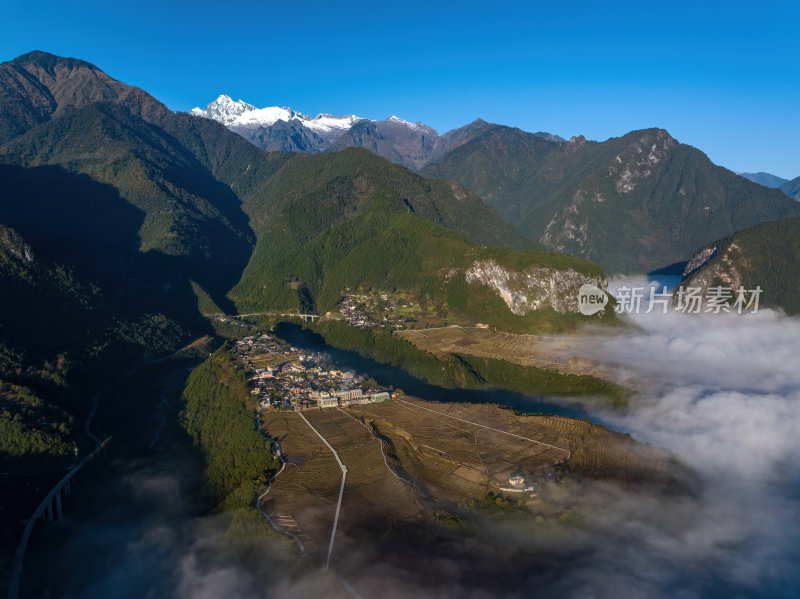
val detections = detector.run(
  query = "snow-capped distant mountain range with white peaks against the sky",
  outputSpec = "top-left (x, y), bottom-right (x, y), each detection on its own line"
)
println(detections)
top-left (191, 95), bottom-right (564, 170)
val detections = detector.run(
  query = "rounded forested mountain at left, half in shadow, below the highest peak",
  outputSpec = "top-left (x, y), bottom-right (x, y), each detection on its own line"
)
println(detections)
top-left (0, 103), bottom-right (253, 310)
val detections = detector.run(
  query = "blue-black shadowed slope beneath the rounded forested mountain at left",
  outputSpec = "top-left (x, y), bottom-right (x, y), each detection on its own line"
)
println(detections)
top-left (0, 165), bottom-right (209, 332)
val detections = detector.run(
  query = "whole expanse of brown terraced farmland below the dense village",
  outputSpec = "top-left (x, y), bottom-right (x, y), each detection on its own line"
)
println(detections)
top-left (262, 397), bottom-right (674, 572)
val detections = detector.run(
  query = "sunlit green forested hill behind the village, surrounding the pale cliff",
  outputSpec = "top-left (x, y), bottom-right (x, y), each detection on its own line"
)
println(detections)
top-left (230, 188), bottom-right (604, 330)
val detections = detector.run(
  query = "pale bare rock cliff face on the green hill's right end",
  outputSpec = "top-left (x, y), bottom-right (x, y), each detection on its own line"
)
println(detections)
top-left (464, 260), bottom-right (608, 316)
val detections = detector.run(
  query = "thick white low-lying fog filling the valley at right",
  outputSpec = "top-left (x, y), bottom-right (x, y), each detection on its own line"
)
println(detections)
top-left (552, 282), bottom-right (800, 597)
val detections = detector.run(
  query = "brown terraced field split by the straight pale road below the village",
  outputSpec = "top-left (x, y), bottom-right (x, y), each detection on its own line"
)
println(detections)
top-left (264, 409), bottom-right (420, 565)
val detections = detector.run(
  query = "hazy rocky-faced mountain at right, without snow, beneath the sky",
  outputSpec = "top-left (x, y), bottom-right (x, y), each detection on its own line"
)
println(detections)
top-left (422, 126), bottom-right (800, 273)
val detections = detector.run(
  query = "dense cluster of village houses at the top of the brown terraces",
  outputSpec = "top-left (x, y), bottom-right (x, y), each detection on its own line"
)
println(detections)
top-left (235, 333), bottom-right (392, 411)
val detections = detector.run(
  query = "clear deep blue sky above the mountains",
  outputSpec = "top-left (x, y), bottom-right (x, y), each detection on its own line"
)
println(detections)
top-left (0, 0), bottom-right (800, 178)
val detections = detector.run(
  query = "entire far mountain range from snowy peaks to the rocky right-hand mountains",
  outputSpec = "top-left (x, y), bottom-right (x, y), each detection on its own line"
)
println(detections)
top-left (192, 95), bottom-right (800, 273)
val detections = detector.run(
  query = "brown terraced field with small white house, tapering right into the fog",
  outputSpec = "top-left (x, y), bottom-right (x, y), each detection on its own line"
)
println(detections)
top-left (350, 397), bottom-right (674, 494)
